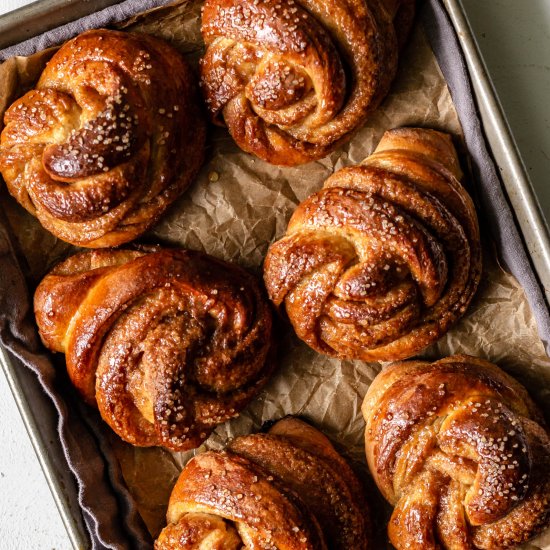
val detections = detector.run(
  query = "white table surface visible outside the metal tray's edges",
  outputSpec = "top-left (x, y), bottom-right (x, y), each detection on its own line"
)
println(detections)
top-left (0, 0), bottom-right (550, 550)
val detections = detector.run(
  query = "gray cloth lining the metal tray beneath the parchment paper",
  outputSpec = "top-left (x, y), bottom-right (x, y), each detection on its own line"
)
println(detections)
top-left (0, 0), bottom-right (550, 549)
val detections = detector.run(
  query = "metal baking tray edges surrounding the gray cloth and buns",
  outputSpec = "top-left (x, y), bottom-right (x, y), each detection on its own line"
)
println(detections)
top-left (0, 0), bottom-right (550, 549)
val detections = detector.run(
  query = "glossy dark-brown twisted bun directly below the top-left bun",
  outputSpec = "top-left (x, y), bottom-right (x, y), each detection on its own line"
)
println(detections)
top-left (34, 249), bottom-right (273, 450)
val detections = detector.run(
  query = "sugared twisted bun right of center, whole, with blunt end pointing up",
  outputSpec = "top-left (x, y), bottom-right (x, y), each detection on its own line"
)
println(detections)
top-left (264, 128), bottom-right (481, 361)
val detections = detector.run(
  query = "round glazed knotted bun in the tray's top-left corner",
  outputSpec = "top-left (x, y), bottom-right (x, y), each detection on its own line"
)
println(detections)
top-left (0, 30), bottom-right (205, 247)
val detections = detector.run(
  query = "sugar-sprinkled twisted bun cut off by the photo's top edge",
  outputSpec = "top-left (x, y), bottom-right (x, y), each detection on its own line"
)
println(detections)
top-left (201, 0), bottom-right (415, 166)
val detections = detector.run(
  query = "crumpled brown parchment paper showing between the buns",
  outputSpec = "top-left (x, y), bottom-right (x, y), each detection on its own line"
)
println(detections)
top-left (0, 1), bottom-right (550, 550)
